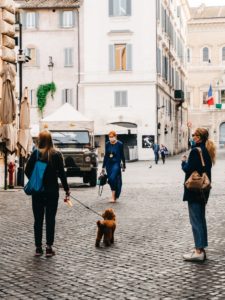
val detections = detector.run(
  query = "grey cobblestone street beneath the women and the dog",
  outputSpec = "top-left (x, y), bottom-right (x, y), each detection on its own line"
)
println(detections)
top-left (0, 152), bottom-right (225, 300)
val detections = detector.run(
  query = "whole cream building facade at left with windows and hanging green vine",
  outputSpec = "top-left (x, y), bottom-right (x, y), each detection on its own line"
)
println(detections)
top-left (15, 0), bottom-right (79, 125)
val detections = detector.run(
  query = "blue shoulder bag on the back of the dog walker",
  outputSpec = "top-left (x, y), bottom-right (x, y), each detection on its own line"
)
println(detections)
top-left (24, 150), bottom-right (47, 196)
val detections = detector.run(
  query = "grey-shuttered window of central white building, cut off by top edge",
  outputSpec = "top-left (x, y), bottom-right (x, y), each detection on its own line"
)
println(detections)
top-left (109, 0), bottom-right (131, 17)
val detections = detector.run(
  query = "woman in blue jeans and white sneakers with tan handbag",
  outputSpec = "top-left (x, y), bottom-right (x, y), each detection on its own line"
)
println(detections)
top-left (181, 128), bottom-right (216, 261)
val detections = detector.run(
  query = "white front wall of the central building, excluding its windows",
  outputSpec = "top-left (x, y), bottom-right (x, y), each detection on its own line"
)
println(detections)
top-left (80, 0), bottom-right (156, 159)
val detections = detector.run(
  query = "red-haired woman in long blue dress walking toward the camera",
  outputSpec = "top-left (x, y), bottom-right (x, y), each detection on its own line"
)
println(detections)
top-left (102, 131), bottom-right (126, 203)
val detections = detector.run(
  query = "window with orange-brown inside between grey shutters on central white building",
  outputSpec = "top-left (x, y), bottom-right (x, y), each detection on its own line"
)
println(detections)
top-left (109, 44), bottom-right (132, 71)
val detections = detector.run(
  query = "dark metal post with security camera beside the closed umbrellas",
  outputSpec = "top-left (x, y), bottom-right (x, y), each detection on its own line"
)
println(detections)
top-left (17, 22), bottom-right (24, 186)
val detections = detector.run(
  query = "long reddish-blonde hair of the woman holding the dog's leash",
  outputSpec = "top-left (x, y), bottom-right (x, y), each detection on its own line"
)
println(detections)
top-left (38, 130), bottom-right (55, 160)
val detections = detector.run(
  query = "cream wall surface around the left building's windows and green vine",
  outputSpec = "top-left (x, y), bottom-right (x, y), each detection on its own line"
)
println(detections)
top-left (23, 9), bottom-right (78, 123)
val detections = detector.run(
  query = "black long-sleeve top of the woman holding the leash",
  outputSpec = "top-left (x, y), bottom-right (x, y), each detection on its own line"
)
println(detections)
top-left (25, 150), bottom-right (69, 193)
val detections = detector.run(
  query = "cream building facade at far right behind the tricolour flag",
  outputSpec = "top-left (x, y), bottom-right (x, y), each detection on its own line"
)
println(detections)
top-left (187, 5), bottom-right (225, 147)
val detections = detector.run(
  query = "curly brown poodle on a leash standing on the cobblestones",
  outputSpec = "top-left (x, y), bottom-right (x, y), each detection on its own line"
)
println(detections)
top-left (95, 208), bottom-right (116, 247)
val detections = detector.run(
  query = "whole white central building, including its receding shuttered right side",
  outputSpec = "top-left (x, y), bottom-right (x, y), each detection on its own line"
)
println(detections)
top-left (79, 0), bottom-right (188, 160)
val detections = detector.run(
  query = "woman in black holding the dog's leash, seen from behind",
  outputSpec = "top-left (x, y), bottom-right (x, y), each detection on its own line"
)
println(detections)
top-left (25, 130), bottom-right (70, 257)
